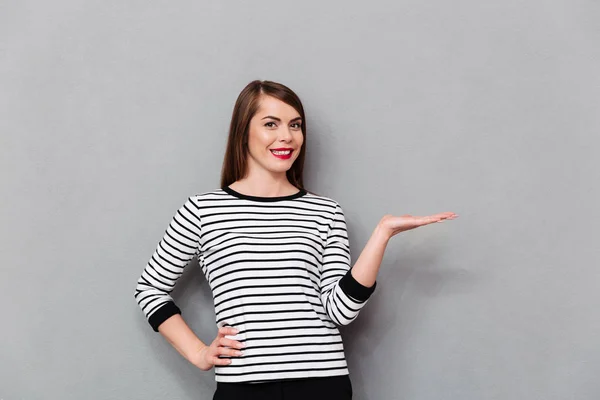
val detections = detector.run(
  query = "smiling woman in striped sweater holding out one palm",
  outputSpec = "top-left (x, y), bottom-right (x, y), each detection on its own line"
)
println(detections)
top-left (135, 81), bottom-right (457, 400)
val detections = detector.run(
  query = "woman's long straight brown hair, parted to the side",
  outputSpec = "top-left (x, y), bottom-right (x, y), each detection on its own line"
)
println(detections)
top-left (221, 80), bottom-right (306, 190)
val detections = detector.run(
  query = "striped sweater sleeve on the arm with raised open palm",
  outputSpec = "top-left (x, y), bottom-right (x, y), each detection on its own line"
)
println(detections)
top-left (321, 203), bottom-right (377, 326)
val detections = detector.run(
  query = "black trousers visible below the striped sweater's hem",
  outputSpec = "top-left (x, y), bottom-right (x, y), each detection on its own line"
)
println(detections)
top-left (213, 375), bottom-right (352, 400)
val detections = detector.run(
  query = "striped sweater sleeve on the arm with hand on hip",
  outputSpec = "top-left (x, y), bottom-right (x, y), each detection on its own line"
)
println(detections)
top-left (134, 198), bottom-right (201, 332)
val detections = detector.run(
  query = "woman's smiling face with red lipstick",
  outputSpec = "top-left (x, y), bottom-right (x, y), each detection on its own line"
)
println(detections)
top-left (248, 95), bottom-right (304, 174)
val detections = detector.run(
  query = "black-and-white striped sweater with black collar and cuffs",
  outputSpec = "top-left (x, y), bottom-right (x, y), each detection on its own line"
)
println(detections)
top-left (134, 186), bottom-right (377, 383)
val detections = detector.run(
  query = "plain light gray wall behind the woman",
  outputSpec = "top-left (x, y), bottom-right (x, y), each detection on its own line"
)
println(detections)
top-left (0, 0), bottom-right (600, 400)
